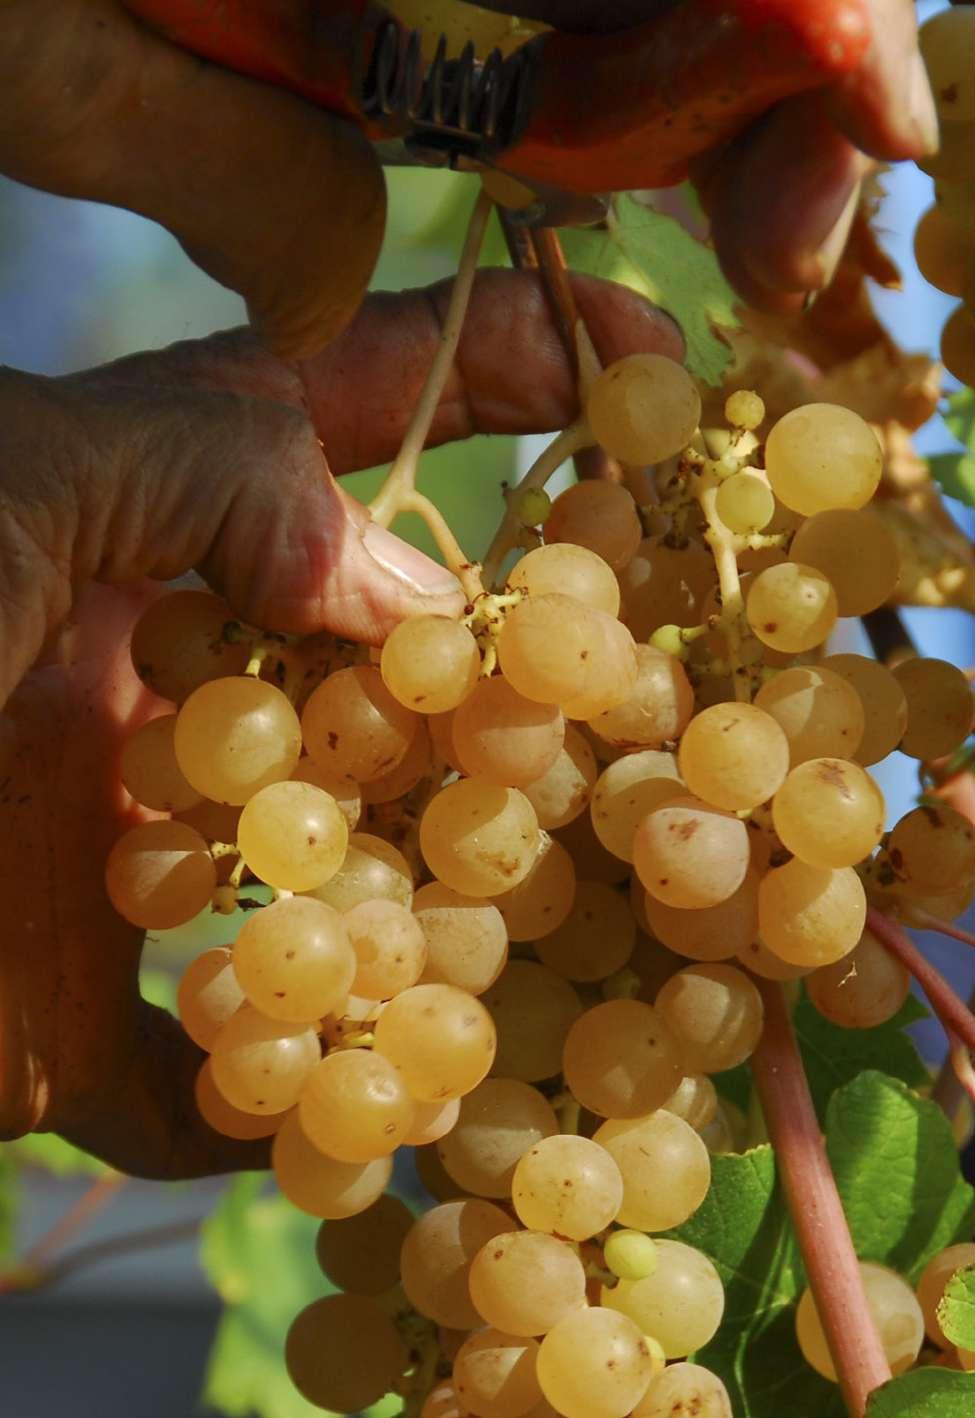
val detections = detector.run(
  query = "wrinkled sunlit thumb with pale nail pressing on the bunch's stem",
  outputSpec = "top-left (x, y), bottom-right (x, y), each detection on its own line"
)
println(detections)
top-left (0, 372), bottom-right (463, 703)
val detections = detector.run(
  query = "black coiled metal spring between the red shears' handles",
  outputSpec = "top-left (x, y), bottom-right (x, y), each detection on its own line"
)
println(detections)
top-left (360, 17), bottom-right (536, 162)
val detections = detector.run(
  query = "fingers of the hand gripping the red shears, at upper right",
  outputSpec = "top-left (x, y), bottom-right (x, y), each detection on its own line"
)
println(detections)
top-left (483, 0), bottom-right (938, 313)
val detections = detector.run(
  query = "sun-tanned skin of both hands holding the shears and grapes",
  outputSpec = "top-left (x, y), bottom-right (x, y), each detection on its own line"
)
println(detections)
top-left (0, 0), bottom-right (928, 1177)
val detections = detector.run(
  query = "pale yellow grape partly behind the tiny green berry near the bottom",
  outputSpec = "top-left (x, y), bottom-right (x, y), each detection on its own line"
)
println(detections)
top-left (602, 1238), bottom-right (724, 1373)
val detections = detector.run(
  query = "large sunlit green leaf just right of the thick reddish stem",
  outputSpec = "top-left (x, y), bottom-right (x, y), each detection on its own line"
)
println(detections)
top-left (826, 1072), bottom-right (975, 1279)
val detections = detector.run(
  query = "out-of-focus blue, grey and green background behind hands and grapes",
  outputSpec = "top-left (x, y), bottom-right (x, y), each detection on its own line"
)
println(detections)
top-left (0, 3), bottom-right (975, 1418)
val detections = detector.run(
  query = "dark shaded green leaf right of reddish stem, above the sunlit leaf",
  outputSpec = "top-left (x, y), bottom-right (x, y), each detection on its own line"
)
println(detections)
top-left (794, 994), bottom-right (928, 1123)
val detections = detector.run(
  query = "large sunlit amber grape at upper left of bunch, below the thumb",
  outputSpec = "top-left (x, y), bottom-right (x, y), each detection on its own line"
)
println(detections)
top-left (173, 675), bottom-right (302, 807)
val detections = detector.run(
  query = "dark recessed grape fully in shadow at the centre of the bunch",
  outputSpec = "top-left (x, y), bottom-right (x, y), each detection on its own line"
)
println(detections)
top-left (535, 879), bottom-right (636, 984)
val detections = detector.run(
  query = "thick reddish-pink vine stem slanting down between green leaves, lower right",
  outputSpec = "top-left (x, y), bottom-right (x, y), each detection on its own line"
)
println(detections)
top-left (751, 980), bottom-right (890, 1418)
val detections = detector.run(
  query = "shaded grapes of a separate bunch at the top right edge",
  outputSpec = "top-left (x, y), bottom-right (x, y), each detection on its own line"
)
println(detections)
top-left (914, 6), bottom-right (975, 384)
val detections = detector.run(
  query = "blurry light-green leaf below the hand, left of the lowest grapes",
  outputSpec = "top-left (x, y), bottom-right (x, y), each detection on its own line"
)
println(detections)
top-left (200, 1173), bottom-right (402, 1418)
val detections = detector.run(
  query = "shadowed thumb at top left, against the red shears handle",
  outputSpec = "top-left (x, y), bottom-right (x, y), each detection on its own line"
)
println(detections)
top-left (0, 0), bottom-right (385, 357)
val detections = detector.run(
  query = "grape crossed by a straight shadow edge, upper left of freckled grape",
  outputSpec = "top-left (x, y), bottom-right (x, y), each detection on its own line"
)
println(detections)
top-left (436, 1078), bottom-right (558, 1197)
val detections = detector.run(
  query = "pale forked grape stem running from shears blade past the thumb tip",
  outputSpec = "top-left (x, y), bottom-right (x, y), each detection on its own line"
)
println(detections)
top-left (368, 182), bottom-right (492, 600)
